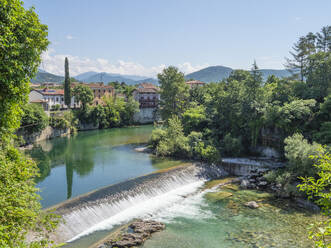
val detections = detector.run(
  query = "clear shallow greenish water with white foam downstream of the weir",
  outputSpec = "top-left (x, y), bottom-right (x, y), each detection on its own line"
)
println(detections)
top-left (68, 180), bottom-right (321, 248)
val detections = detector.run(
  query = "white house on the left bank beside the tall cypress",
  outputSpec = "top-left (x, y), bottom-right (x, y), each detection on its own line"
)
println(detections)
top-left (29, 88), bottom-right (80, 111)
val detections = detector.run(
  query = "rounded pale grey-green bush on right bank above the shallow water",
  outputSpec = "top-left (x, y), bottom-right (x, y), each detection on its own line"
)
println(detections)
top-left (284, 133), bottom-right (324, 176)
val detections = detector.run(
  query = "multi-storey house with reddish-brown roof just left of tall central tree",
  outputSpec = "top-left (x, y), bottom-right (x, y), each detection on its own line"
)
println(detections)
top-left (133, 83), bottom-right (160, 123)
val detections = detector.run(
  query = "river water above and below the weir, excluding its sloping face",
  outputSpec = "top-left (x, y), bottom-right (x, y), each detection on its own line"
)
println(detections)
top-left (29, 126), bottom-right (320, 248)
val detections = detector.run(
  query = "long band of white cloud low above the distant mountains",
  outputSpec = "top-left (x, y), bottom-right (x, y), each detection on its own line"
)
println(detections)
top-left (41, 49), bottom-right (208, 77)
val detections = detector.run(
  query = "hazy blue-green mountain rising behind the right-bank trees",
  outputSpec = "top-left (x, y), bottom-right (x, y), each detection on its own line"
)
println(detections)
top-left (185, 66), bottom-right (291, 83)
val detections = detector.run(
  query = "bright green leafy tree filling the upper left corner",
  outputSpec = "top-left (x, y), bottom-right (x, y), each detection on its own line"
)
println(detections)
top-left (0, 0), bottom-right (49, 141)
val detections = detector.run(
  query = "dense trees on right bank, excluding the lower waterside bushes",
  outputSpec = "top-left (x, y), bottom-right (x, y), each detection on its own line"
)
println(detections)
top-left (154, 27), bottom-right (331, 160)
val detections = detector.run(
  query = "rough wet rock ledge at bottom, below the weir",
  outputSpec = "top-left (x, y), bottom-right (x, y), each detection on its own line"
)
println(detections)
top-left (94, 220), bottom-right (165, 248)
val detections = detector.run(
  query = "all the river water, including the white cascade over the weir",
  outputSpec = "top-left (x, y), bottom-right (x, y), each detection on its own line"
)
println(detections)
top-left (30, 126), bottom-right (321, 248)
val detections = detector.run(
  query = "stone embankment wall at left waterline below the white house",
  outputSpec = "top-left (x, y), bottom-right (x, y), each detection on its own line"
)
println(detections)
top-left (17, 126), bottom-right (70, 145)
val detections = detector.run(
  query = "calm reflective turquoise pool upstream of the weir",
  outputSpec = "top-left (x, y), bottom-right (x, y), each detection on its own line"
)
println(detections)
top-left (29, 125), bottom-right (184, 208)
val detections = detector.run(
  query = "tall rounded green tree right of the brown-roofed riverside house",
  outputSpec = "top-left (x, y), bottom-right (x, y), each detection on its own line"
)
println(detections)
top-left (158, 66), bottom-right (189, 120)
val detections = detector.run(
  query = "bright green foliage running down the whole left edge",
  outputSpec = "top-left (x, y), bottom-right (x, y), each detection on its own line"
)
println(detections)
top-left (0, 0), bottom-right (56, 247)
